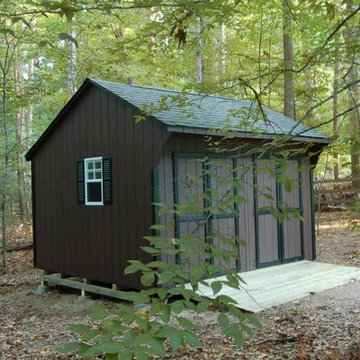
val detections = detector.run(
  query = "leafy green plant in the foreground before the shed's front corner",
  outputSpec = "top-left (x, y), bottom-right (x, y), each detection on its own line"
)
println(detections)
top-left (57, 226), bottom-right (261, 360)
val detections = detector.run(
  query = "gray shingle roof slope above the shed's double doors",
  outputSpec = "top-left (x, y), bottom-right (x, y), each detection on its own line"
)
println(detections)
top-left (90, 79), bottom-right (327, 139)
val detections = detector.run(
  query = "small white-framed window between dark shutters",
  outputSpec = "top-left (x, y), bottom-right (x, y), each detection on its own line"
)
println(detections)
top-left (84, 157), bottom-right (104, 205)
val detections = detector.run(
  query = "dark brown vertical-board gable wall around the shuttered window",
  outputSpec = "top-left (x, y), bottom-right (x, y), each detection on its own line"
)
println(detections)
top-left (33, 86), bottom-right (168, 287)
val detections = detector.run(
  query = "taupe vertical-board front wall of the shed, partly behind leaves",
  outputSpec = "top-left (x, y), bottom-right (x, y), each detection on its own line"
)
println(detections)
top-left (159, 135), bottom-right (312, 271)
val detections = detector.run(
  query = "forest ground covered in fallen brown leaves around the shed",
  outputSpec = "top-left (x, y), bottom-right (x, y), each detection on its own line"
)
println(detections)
top-left (0, 212), bottom-right (360, 360)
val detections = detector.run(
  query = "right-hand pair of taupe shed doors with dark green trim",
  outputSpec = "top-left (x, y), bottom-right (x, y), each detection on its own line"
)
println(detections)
top-left (254, 159), bottom-right (304, 267)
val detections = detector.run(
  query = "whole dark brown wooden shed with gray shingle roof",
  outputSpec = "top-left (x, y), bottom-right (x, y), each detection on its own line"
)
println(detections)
top-left (26, 79), bottom-right (328, 288)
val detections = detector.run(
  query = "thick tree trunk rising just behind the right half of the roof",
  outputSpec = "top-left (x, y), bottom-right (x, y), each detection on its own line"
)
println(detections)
top-left (283, 0), bottom-right (295, 119)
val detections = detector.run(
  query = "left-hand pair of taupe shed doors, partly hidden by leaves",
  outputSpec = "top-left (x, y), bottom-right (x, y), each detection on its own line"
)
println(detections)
top-left (174, 153), bottom-right (240, 270)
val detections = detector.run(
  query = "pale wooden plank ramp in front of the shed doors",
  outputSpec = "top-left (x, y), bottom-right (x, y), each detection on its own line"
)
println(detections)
top-left (199, 260), bottom-right (360, 313)
